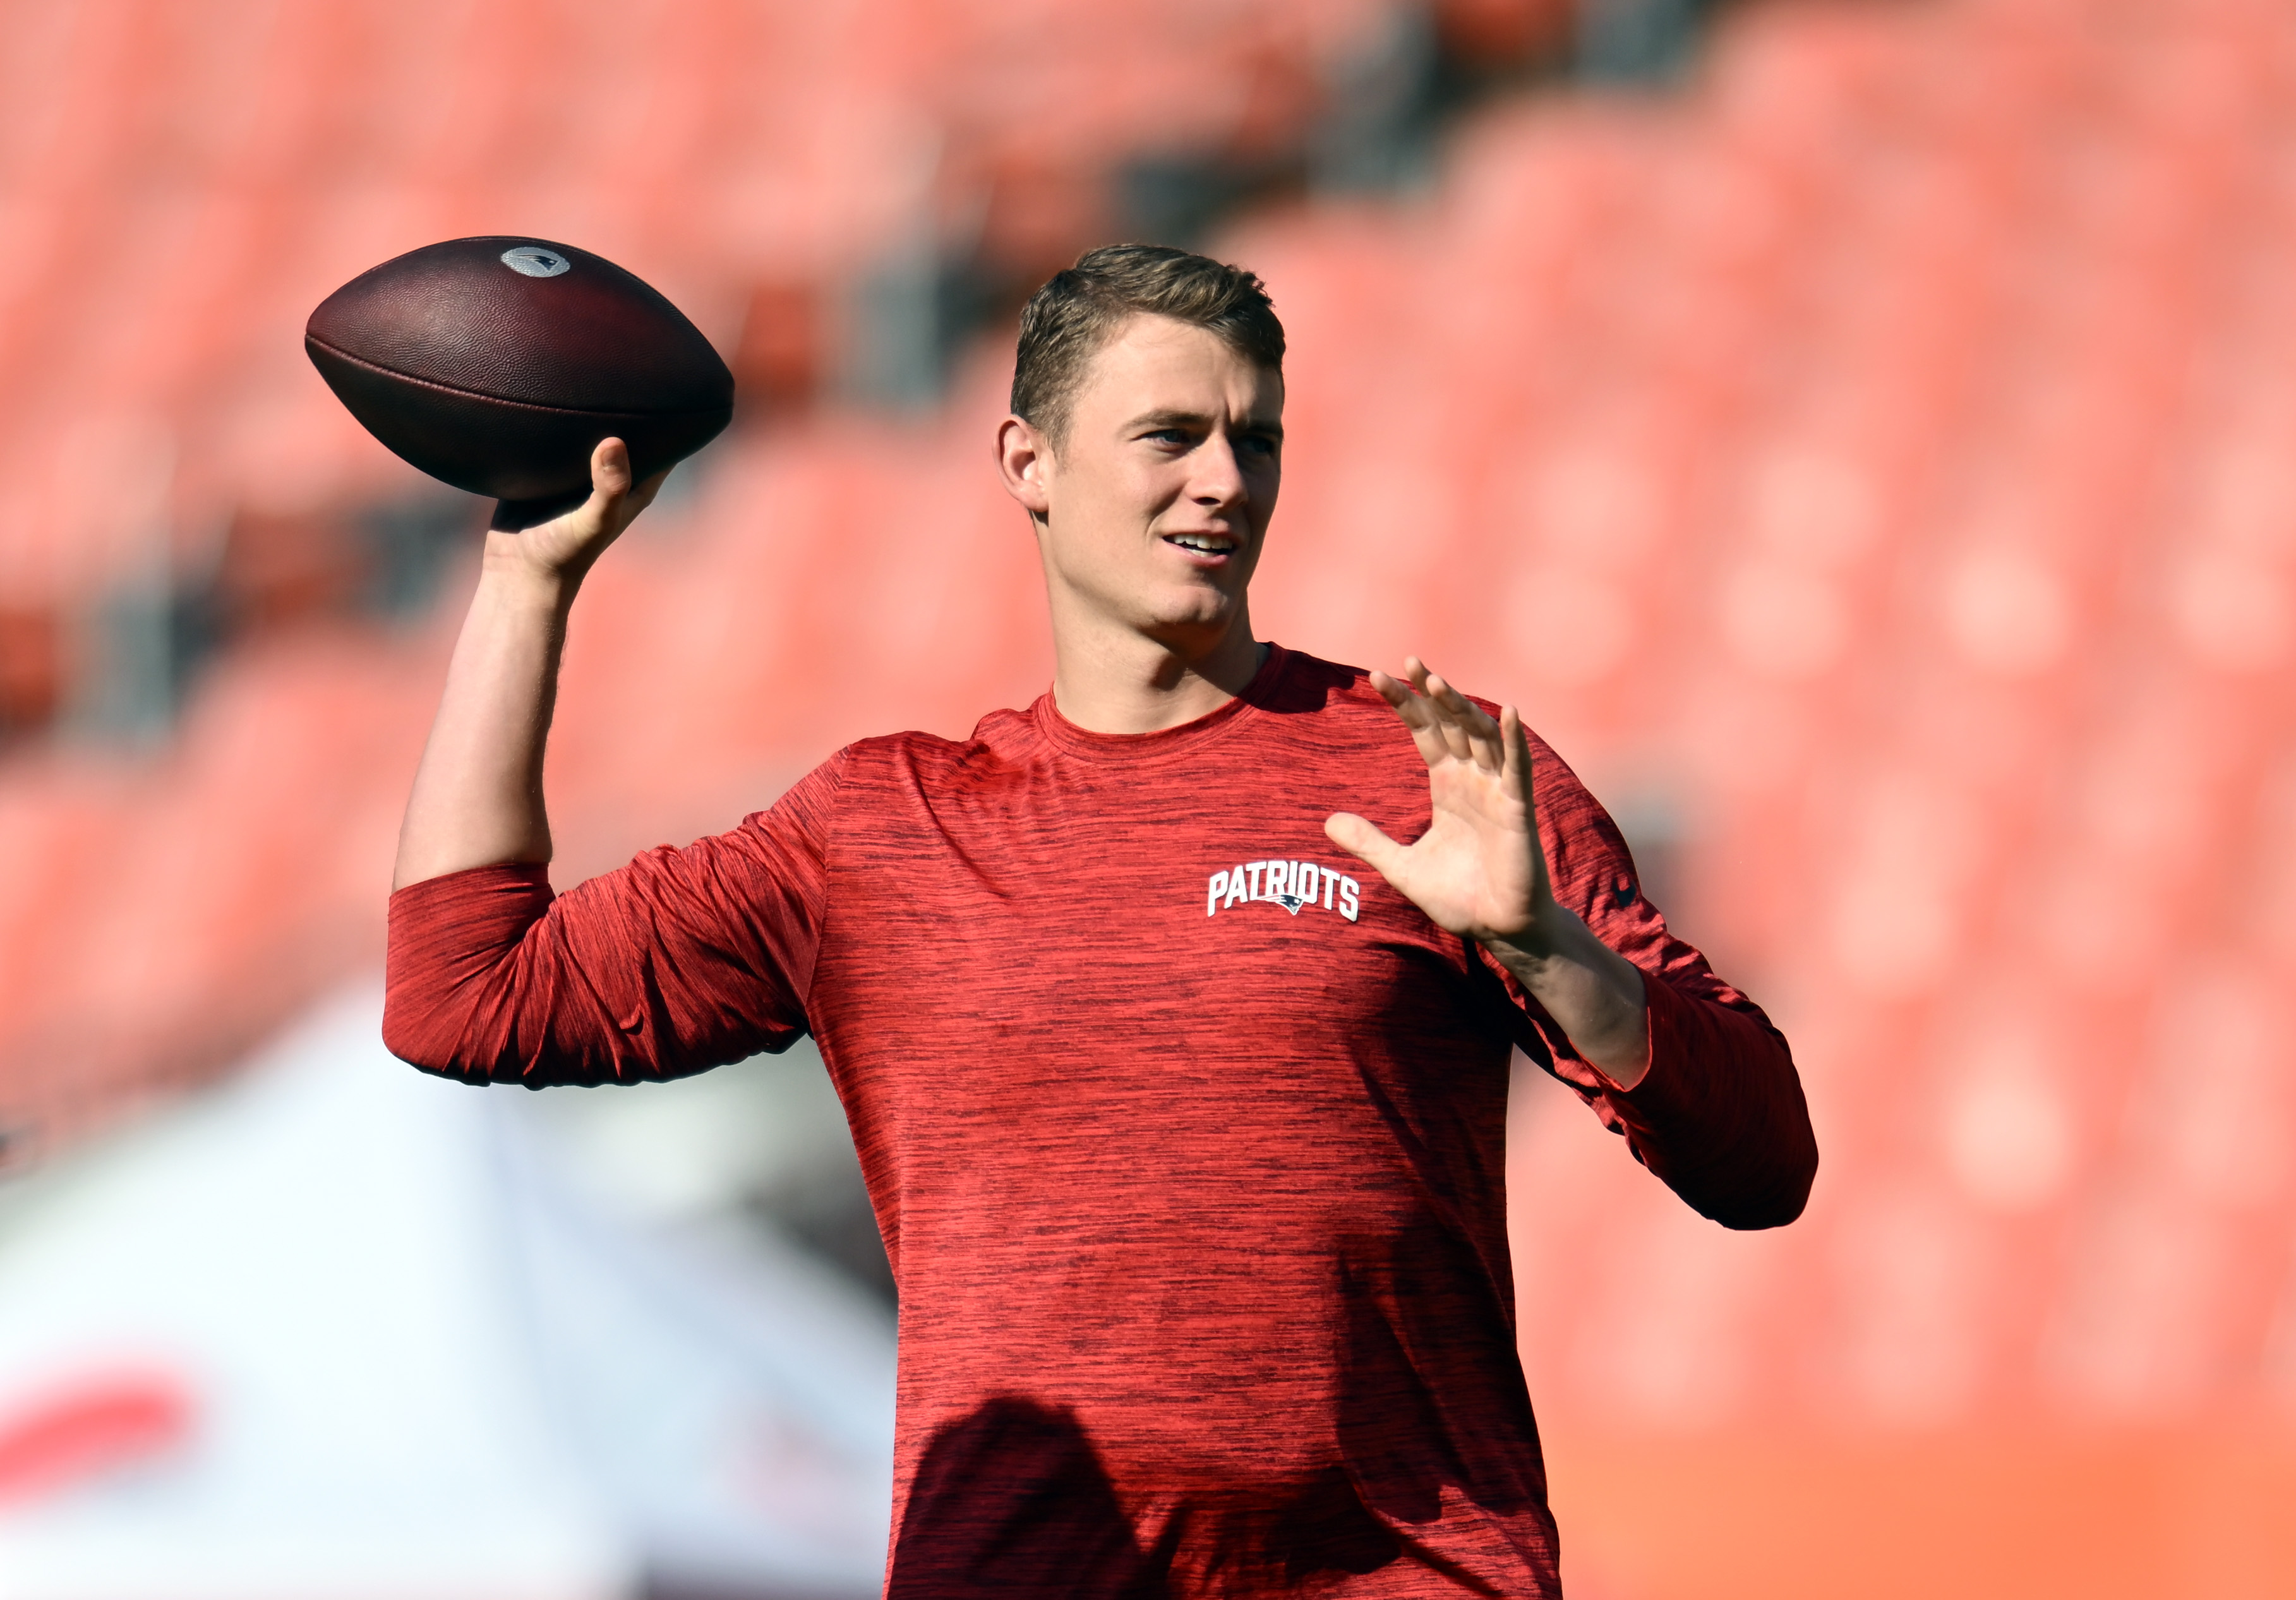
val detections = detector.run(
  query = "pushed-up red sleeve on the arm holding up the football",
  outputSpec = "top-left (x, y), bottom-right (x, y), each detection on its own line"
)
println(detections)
top-left (383, 760), bottom-right (840, 1088)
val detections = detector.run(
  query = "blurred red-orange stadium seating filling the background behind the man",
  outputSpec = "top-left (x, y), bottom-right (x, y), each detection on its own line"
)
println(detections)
top-left (0, 0), bottom-right (2296, 1600)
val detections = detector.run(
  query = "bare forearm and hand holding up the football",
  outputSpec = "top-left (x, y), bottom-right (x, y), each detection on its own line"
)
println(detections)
top-left (390, 438), bottom-right (661, 888)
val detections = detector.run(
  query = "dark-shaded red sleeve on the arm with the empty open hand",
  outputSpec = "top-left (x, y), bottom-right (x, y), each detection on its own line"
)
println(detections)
top-left (1481, 746), bottom-right (1818, 1228)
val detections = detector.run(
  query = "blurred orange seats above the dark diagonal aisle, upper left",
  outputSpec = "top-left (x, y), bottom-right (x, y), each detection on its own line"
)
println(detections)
top-left (0, 0), bottom-right (1389, 620)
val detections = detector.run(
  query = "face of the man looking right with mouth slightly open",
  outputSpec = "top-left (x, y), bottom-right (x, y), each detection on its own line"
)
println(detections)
top-left (1001, 317), bottom-right (1283, 654)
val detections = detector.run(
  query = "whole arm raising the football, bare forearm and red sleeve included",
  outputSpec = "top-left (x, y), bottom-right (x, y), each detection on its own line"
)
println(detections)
top-left (383, 441), bottom-right (838, 1088)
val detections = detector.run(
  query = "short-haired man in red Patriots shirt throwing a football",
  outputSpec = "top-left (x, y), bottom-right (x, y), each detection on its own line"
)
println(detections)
top-left (386, 246), bottom-right (1816, 1600)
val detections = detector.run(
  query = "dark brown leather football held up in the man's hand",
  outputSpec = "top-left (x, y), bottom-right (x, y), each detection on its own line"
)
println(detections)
top-left (303, 234), bottom-right (733, 528)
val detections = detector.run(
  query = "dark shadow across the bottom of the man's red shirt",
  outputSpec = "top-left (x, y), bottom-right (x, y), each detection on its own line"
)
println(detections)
top-left (886, 1217), bottom-right (1552, 1600)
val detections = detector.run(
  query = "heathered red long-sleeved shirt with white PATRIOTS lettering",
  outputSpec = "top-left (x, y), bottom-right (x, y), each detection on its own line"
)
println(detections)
top-left (383, 649), bottom-right (1816, 1600)
